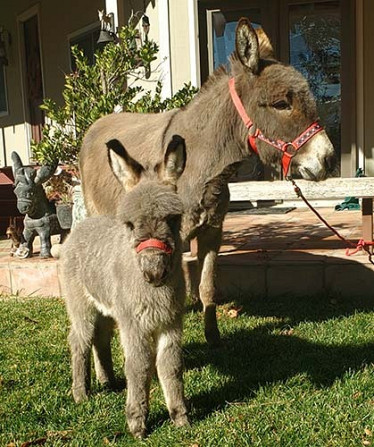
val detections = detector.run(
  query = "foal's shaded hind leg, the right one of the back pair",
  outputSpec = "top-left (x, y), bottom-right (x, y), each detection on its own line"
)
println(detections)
top-left (93, 315), bottom-right (115, 388)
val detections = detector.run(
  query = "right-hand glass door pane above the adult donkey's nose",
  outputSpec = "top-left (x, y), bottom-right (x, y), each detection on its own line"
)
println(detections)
top-left (288, 1), bottom-right (341, 173)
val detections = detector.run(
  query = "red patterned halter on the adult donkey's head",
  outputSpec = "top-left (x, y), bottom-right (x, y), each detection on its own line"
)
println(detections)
top-left (229, 78), bottom-right (323, 177)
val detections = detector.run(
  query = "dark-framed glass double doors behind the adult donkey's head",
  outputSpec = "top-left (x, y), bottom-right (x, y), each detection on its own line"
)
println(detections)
top-left (198, 0), bottom-right (346, 179)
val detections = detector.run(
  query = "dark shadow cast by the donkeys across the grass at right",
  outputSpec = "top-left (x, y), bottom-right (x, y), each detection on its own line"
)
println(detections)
top-left (184, 298), bottom-right (374, 420)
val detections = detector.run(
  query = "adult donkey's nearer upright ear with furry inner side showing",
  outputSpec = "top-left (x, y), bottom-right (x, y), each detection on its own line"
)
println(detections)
top-left (235, 17), bottom-right (260, 74)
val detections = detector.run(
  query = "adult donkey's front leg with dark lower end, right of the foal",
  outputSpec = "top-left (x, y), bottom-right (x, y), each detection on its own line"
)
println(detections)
top-left (197, 227), bottom-right (222, 345)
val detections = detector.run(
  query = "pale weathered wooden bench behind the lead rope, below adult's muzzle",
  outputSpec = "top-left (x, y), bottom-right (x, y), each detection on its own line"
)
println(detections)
top-left (229, 177), bottom-right (374, 248)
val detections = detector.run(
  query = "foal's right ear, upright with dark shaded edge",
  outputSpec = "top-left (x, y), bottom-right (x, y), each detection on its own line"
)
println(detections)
top-left (162, 135), bottom-right (186, 186)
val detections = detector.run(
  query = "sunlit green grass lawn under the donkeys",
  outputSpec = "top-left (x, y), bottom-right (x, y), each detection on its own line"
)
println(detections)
top-left (0, 297), bottom-right (374, 447)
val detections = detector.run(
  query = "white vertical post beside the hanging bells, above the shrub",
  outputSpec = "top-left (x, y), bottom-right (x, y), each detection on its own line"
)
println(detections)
top-left (158, 0), bottom-right (173, 99)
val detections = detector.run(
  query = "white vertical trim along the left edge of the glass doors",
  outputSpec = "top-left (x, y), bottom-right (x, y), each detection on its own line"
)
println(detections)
top-left (188, 0), bottom-right (201, 88)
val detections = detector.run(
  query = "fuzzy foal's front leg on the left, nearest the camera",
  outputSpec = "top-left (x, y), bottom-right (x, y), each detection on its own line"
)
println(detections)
top-left (120, 327), bottom-right (155, 438)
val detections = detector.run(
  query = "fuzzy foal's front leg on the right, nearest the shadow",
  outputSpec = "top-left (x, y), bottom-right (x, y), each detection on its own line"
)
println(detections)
top-left (156, 324), bottom-right (189, 427)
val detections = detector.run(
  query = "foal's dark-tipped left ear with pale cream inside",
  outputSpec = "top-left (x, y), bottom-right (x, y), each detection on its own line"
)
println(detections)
top-left (106, 140), bottom-right (144, 191)
